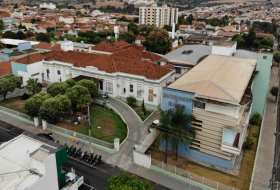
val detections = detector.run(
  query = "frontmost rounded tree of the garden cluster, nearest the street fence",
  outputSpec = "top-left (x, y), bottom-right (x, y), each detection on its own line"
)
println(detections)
top-left (39, 95), bottom-right (71, 124)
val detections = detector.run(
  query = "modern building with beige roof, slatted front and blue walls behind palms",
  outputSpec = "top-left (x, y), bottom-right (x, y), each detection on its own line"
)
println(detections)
top-left (162, 55), bottom-right (257, 169)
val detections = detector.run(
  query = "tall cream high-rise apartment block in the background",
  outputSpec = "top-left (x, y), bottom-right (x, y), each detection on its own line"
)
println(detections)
top-left (139, 4), bottom-right (178, 27)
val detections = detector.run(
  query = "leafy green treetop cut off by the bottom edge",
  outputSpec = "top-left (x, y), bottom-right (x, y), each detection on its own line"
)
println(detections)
top-left (105, 174), bottom-right (153, 190)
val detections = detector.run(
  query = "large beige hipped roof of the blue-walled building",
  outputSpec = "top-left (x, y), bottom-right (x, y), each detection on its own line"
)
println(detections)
top-left (168, 55), bottom-right (257, 104)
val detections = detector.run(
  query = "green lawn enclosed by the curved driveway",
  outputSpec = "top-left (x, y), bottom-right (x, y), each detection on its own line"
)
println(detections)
top-left (57, 106), bottom-right (127, 143)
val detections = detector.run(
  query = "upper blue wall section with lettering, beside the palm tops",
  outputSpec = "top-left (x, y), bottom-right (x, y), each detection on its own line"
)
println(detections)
top-left (161, 88), bottom-right (194, 114)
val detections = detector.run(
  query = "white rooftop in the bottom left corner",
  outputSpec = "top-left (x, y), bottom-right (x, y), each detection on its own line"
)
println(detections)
top-left (0, 134), bottom-right (61, 189)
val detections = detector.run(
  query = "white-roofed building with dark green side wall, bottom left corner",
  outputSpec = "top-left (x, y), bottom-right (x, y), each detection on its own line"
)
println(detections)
top-left (0, 133), bottom-right (67, 190)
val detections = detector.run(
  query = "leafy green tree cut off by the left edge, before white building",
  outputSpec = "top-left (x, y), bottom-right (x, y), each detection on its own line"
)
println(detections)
top-left (0, 73), bottom-right (21, 99)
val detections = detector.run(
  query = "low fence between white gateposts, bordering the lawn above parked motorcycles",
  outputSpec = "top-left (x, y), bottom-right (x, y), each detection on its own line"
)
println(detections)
top-left (47, 123), bottom-right (114, 149)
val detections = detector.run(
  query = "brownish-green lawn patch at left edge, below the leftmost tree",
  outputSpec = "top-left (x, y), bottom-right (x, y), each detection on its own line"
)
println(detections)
top-left (0, 97), bottom-right (26, 114)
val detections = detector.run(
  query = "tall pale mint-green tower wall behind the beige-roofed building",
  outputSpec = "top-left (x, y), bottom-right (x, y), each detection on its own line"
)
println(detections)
top-left (251, 53), bottom-right (273, 115)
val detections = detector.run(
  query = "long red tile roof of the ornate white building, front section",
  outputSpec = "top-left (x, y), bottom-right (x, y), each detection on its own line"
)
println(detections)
top-left (44, 49), bottom-right (171, 80)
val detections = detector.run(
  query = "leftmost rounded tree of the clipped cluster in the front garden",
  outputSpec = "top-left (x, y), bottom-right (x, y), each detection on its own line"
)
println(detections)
top-left (24, 92), bottom-right (52, 117)
